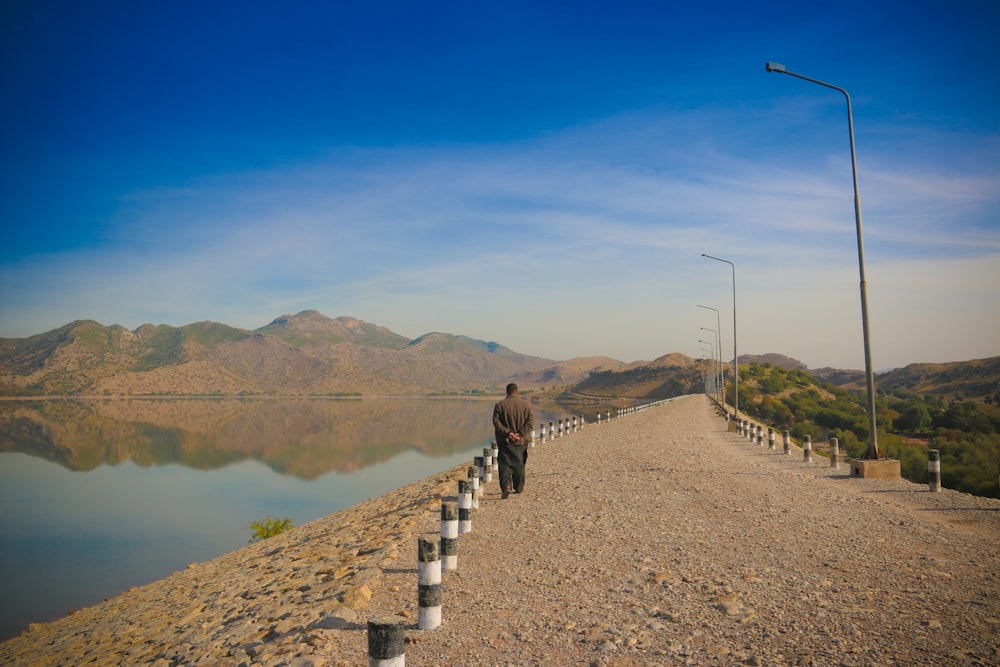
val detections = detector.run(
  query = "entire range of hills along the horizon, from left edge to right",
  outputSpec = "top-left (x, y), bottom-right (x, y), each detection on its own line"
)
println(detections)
top-left (0, 310), bottom-right (1000, 399)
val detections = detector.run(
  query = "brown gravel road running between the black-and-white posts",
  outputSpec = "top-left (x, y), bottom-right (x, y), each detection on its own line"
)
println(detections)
top-left (372, 396), bottom-right (1000, 666)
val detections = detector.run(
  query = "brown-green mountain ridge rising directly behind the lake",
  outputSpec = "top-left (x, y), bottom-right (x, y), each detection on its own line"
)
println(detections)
top-left (0, 310), bottom-right (608, 396)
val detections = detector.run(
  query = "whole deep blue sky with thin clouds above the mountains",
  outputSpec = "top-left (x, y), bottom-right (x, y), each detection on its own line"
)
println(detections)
top-left (0, 0), bottom-right (1000, 369)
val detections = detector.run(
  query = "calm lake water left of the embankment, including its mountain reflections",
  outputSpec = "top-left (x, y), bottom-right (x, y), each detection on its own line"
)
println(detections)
top-left (0, 398), bottom-right (569, 640)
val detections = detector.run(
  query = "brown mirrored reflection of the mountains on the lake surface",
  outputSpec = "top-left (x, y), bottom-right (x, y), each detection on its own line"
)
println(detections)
top-left (0, 398), bottom-right (549, 479)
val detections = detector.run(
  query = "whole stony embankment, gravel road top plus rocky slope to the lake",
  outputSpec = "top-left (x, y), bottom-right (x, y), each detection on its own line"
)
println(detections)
top-left (0, 396), bottom-right (1000, 667)
